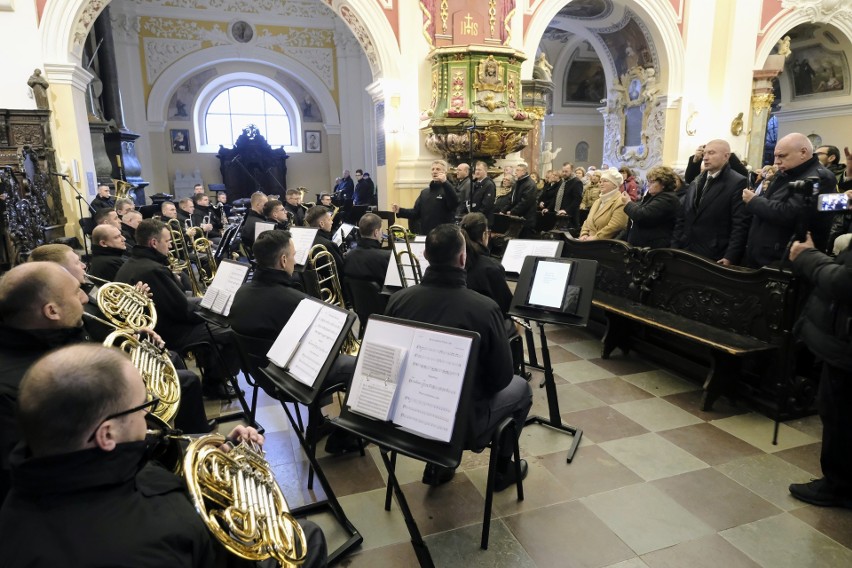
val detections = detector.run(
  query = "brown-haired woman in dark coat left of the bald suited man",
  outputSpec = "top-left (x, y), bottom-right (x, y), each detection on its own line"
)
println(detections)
top-left (621, 166), bottom-right (680, 248)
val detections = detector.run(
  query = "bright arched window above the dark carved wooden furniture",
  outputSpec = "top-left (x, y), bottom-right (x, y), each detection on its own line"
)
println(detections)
top-left (204, 85), bottom-right (293, 147)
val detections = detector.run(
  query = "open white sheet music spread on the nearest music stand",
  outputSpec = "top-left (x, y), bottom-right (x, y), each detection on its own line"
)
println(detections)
top-left (347, 320), bottom-right (472, 442)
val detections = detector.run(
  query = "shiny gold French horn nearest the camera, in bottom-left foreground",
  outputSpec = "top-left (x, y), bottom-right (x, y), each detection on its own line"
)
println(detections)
top-left (148, 415), bottom-right (307, 568)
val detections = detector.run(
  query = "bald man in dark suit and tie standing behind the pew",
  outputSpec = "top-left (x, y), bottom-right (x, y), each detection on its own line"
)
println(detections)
top-left (672, 140), bottom-right (749, 266)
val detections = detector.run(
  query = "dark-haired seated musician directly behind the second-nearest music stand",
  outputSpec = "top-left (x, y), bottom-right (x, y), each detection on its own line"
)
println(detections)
top-left (228, 231), bottom-right (359, 453)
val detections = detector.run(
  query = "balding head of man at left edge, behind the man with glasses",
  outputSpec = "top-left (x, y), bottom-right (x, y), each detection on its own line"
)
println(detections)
top-left (0, 262), bottom-right (85, 329)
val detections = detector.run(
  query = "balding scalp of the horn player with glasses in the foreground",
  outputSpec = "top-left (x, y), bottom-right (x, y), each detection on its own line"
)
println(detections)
top-left (18, 344), bottom-right (136, 456)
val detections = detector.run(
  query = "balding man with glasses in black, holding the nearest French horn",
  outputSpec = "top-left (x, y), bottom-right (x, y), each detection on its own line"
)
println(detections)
top-left (0, 345), bottom-right (326, 568)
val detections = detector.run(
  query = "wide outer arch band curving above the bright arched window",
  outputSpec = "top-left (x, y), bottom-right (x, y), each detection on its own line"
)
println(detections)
top-left (146, 45), bottom-right (340, 128)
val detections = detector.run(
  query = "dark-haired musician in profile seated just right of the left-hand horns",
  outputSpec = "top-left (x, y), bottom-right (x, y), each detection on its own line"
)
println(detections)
top-left (115, 219), bottom-right (237, 398)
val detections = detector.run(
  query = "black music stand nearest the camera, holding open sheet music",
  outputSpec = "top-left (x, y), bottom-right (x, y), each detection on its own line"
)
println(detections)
top-left (334, 315), bottom-right (480, 567)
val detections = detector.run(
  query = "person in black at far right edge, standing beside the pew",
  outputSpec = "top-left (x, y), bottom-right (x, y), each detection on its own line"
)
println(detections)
top-left (790, 235), bottom-right (852, 509)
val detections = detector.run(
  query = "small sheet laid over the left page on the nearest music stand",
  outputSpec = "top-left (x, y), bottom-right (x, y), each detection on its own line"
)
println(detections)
top-left (348, 343), bottom-right (405, 420)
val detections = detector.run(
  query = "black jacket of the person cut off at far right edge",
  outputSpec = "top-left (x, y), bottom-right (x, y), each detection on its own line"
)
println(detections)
top-left (793, 249), bottom-right (852, 371)
